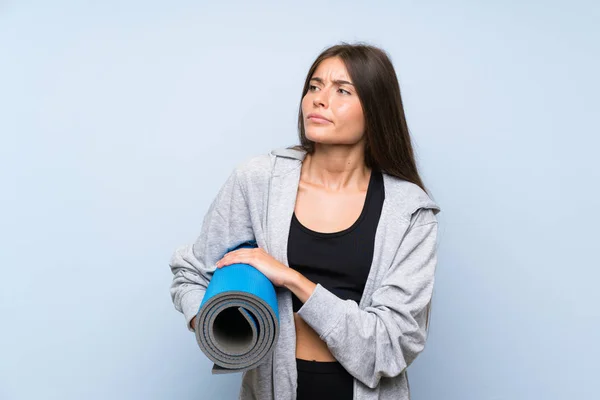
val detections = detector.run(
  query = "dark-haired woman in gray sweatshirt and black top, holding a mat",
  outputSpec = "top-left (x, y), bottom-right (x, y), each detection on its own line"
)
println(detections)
top-left (170, 44), bottom-right (440, 400)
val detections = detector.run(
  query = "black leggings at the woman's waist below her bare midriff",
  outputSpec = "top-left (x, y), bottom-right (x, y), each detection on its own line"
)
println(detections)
top-left (296, 358), bottom-right (354, 400)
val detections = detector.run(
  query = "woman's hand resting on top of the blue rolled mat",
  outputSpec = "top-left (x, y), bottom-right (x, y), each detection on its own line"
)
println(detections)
top-left (216, 247), bottom-right (294, 286)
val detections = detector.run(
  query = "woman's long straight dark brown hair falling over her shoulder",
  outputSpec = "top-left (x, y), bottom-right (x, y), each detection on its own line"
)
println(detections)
top-left (290, 42), bottom-right (427, 192)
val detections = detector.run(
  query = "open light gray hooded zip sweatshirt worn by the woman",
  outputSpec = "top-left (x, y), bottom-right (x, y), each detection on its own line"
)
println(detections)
top-left (170, 148), bottom-right (440, 400)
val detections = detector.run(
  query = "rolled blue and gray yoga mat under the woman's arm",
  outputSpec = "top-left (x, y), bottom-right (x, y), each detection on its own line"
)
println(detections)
top-left (195, 241), bottom-right (279, 374)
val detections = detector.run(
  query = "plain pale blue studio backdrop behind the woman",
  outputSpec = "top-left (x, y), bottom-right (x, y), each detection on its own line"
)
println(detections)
top-left (0, 0), bottom-right (600, 400)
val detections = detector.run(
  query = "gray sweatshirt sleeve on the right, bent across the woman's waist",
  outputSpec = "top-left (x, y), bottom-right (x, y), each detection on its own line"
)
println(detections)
top-left (298, 208), bottom-right (438, 388)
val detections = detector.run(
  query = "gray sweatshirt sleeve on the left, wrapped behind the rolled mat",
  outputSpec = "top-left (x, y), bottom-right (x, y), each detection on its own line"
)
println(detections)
top-left (169, 167), bottom-right (254, 332)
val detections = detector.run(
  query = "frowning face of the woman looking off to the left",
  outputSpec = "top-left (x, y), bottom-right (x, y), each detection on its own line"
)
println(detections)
top-left (302, 57), bottom-right (365, 144)
